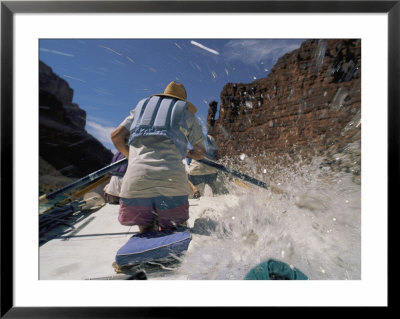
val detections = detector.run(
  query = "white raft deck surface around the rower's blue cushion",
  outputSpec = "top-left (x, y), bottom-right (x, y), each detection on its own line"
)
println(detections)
top-left (39, 195), bottom-right (238, 280)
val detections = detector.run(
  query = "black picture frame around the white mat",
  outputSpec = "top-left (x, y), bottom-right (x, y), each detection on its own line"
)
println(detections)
top-left (0, 0), bottom-right (394, 318)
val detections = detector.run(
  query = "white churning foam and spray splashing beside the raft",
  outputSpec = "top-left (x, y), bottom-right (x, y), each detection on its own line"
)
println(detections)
top-left (175, 158), bottom-right (361, 280)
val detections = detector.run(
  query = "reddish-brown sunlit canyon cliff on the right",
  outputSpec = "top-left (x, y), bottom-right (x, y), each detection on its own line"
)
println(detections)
top-left (208, 39), bottom-right (361, 175)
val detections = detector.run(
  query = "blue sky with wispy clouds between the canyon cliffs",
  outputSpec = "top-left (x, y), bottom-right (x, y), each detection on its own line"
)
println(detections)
top-left (39, 39), bottom-right (304, 152)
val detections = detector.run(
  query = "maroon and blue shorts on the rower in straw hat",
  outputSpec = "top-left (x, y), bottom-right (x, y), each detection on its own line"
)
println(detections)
top-left (118, 195), bottom-right (189, 228)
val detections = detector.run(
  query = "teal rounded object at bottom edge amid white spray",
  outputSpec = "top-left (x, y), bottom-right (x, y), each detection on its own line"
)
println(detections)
top-left (244, 259), bottom-right (308, 280)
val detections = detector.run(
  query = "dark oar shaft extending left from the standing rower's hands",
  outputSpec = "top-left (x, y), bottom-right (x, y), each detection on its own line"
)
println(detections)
top-left (39, 158), bottom-right (127, 204)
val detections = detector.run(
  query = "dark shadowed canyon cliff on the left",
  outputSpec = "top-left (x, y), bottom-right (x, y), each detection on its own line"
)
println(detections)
top-left (39, 62), bottom-right (113, 186)
